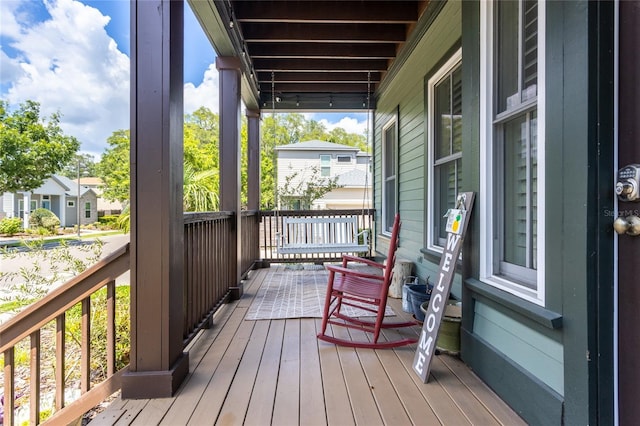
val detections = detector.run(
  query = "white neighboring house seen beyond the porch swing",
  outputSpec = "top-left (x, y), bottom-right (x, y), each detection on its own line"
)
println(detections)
top-left (276, 140), bottom-right (373, 210)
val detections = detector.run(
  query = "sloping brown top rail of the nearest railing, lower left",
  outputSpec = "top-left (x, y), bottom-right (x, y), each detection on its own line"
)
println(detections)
top-left (0, 243), bottom-right (129, 353)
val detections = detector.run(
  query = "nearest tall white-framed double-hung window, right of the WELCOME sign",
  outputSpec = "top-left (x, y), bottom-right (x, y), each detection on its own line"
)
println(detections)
top-left (480, 0), bottom-right (544, 305)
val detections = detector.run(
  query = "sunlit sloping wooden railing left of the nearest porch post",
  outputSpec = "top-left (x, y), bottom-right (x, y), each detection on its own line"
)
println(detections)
top-left (0, 244), bottom-right (129, 425)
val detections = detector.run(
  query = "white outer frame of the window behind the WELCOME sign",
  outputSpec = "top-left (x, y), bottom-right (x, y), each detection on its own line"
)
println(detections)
top-left (427, 48), bottom-right (462, 253)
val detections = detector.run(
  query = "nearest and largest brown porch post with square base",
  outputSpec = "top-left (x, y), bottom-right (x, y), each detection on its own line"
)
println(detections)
top-left (122, 0), bottom-right (189, 398)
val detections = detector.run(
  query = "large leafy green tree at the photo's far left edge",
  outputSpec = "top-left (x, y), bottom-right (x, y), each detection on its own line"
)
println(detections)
top-left (0, 100), bottom-right (80, 193)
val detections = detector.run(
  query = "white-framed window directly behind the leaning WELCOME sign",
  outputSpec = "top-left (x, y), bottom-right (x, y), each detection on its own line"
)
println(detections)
top-left (427, 50), bottom-right (462, 251)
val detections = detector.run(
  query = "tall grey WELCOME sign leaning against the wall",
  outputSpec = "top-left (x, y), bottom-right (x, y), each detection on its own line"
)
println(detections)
top-left (413, 192), bottom-right (474, 383)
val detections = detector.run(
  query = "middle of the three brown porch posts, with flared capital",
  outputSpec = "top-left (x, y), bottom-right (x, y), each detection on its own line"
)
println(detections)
top-left (216, 57), bottom-right (243, 298)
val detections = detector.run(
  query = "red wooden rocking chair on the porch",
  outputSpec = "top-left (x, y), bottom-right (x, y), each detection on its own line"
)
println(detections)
top-left (318, 215), bottom-right (417, 348)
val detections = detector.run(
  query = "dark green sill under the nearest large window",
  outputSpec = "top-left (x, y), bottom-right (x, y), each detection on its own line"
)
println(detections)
top-left (465, 278), bottom-right (562, 330)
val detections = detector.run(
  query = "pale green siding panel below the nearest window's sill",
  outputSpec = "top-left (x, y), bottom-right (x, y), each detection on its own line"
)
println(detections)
top-left (473, 301), bottom-right (564, 395)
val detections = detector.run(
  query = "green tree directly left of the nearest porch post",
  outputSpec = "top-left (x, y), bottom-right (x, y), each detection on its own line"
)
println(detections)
top-left (96, 130), bottom-right (131, 202)
